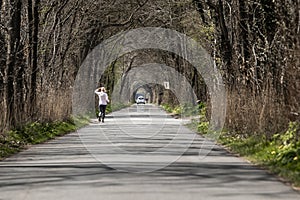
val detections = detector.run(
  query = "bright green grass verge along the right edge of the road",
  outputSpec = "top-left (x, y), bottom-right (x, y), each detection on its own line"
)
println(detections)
top-left (189, 121), bottom-right (300, 188)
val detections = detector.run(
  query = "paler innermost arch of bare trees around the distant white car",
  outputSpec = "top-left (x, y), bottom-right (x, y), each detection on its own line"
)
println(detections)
top-left (112, 63), bottom-right (197, 108)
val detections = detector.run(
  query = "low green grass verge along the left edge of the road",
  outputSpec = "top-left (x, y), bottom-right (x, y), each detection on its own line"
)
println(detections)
top-left (0, 117), bottom-right (89, 160)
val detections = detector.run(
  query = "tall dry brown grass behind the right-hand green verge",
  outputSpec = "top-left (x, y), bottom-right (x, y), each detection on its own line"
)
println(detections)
top-left (226, 84), bottom-right (290, 136)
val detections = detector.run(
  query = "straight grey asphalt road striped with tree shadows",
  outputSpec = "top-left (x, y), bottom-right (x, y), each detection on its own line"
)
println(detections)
top-left (0, 105), bottom-right (300, 200)
